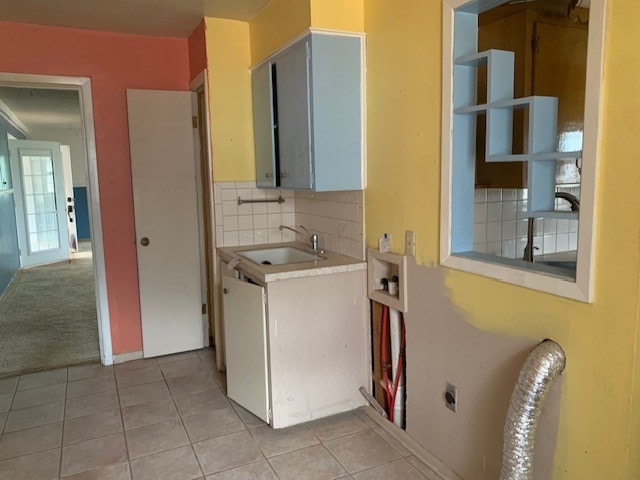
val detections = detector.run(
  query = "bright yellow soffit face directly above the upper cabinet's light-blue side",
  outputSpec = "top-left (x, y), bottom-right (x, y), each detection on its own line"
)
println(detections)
top-left (310, 0), bottom-right (365, 32)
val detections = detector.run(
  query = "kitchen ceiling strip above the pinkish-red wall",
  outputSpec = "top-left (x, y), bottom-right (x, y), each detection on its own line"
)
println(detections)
top-left (0, 0), bottom-right (269, 38)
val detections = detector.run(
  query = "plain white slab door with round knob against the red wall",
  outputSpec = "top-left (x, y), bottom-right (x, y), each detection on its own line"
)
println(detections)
top-left (127, 90), bottom-right (205, 357)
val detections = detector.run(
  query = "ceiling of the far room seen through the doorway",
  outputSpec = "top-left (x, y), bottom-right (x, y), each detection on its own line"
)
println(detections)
top-left (0, 87), bottom-right (82, 130)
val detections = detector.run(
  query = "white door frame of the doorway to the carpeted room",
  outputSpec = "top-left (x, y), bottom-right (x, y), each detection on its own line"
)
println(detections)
top-left (0, 72), bottom-right (113, 365)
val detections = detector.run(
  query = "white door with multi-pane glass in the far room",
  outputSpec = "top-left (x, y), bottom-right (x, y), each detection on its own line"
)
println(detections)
top-left (9, 140), bottom-right (69, 267)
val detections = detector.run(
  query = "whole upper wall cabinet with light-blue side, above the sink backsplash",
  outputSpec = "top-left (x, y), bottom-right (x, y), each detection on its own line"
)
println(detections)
top-left (252, 32), bottom-right (364, 191)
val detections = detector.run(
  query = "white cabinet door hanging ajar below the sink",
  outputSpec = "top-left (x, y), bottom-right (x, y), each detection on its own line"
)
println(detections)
top-left (222, 276), bottom-right (269, 422)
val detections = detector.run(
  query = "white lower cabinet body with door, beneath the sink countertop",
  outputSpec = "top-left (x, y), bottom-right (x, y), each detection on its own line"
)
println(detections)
top-left (222, 264), bottom-right (370, 428)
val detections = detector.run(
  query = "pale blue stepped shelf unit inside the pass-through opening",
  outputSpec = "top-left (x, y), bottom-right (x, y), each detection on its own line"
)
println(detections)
top-left (452, 44), bottom-right (582, 244)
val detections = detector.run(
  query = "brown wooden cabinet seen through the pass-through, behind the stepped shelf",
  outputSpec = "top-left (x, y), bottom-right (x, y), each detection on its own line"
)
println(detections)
top-left (476, 5), bottom-right (588, 188)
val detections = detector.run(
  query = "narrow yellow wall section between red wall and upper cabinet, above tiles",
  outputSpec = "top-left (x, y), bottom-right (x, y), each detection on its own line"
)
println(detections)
top-left (205, 18), bottom-right (256, 182)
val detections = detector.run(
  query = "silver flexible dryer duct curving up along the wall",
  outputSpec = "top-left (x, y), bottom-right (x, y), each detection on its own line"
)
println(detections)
top-left (500, 340), bottom-right (566, 480)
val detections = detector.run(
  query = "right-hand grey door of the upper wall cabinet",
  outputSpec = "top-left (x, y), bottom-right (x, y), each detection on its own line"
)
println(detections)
top-left (276, 41), bottom-right (313, 189)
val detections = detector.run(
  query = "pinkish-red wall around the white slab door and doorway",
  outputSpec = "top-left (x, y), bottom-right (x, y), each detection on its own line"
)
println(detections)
top-left (0, 22), bottom-right (189, 353)
